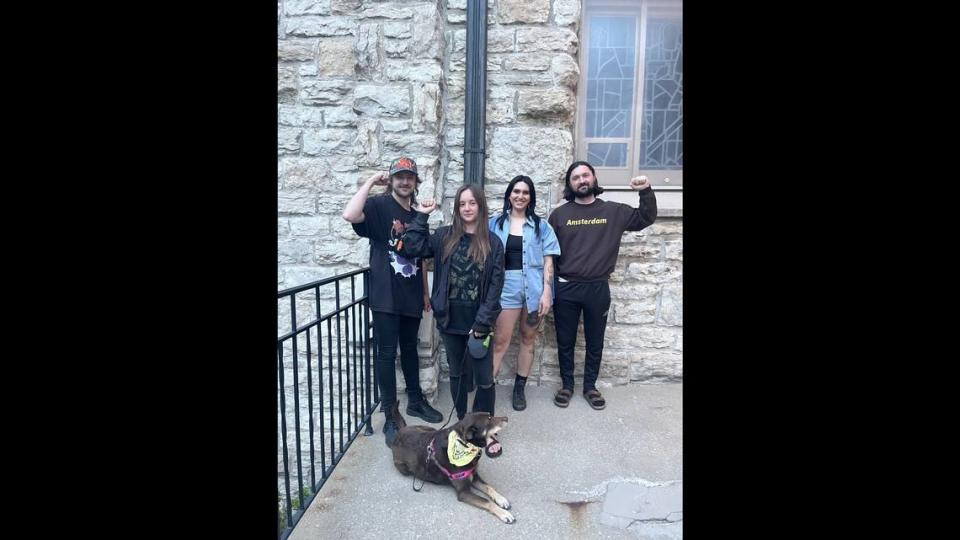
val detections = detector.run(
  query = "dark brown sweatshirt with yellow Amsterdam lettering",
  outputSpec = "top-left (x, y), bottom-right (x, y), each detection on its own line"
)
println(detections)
top-left (547, 188), bottom-right (657, 281)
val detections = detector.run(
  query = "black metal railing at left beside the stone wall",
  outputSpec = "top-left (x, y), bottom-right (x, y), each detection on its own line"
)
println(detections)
top-left (277, 268), bottom-right (380, 540)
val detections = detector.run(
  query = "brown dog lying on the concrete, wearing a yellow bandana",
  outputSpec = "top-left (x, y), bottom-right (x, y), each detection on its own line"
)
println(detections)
top-left (390, 402), bottom-right (516, 523)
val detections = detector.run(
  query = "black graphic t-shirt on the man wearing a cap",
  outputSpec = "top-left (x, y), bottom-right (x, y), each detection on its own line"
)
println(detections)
top-left (353, 193), bottom-right (423, 319)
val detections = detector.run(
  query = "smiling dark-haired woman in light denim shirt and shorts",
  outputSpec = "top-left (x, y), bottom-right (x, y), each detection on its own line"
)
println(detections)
top-left (490, 175), bottom-right (560, 411)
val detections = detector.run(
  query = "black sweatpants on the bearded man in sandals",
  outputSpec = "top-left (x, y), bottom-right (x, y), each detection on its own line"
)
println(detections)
top-left (553, 280), bottom-right (610, 392)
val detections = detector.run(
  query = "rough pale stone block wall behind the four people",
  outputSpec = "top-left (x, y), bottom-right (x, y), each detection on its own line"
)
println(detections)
top-left (277, 0), bottom-right (683, 397)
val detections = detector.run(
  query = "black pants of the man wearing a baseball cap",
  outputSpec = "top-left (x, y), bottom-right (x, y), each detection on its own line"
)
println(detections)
top-left (373, 311), bottom-right (423, 414)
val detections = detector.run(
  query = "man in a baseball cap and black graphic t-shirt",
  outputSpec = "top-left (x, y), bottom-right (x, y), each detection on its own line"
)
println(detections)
top-left (343, 157), bottom-right (443, 446)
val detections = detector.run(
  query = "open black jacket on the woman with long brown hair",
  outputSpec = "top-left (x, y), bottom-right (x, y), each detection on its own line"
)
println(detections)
top-left (398, 212), bottom-right (503, 334)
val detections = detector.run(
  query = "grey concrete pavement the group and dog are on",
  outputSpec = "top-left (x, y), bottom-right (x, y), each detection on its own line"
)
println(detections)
top-left (290, 383), bottom-right (683, 540)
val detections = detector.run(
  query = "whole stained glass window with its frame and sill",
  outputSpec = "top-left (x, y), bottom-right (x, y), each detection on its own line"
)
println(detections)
top-left (577, 0), bottom-right (683, 189)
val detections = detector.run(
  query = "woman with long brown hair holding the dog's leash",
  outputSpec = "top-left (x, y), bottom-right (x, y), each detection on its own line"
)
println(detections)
top-left (400, 184), bottom-right (504, 438)
